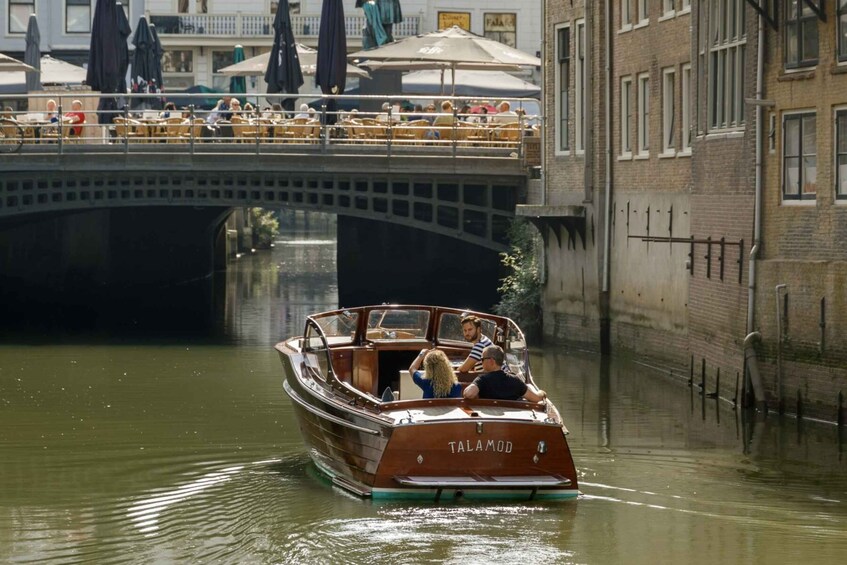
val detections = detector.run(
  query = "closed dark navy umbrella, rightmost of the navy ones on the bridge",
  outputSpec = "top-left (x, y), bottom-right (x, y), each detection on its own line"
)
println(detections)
top-left (315, 0), bottom-right (347, 124)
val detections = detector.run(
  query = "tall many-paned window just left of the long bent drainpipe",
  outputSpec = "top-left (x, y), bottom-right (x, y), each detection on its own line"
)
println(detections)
top-left (708, 0), bottom-right (744, 129)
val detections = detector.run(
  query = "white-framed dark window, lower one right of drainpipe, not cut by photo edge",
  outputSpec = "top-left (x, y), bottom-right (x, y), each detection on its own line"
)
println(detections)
top-left (782, 114), bottom-right (818, 200)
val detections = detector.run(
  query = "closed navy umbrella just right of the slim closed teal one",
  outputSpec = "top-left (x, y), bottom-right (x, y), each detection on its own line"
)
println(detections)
top-left (260, 0), bottom-right (303, 111)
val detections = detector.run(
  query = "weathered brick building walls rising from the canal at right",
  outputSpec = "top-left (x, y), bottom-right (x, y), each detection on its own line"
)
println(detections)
top-left (544, 0), bottom-right (847, 423)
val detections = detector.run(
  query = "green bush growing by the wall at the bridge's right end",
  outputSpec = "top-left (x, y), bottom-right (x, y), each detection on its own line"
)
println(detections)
top-left (494, 219), bottom-right (541, 336)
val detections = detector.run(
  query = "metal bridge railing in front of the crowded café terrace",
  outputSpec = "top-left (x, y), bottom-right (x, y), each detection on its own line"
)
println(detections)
top-left (0, 92), bottom-right (541, 159)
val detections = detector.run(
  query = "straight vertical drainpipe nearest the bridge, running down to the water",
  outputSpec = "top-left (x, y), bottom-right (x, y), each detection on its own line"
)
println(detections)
top-left (600, 0), bottom-right (612, 350)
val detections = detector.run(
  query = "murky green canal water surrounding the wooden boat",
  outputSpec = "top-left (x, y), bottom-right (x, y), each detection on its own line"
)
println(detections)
top-left (0, 219), bottom-right (847, 565)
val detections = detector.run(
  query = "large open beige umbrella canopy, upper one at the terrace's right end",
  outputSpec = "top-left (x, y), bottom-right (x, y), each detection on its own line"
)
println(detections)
top-left (349, 26), bottom-right (541, 69)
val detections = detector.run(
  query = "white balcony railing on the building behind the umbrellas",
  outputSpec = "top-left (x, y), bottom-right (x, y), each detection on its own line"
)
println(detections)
top-left (148, 13), bottom-right (420, 38)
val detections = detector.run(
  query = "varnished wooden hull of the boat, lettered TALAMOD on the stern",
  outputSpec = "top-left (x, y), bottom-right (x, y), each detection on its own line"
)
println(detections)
top-left (277, 344), bottom-right (579, 500)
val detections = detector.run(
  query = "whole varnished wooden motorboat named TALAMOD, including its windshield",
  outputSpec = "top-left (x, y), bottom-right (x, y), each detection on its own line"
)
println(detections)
top-left (276, 305), bottom-right (579, 500)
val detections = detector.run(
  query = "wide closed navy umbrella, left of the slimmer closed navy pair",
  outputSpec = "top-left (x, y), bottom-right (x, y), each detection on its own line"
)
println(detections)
top-left (86, 0), bottom-right (129, 124)
